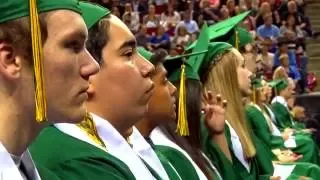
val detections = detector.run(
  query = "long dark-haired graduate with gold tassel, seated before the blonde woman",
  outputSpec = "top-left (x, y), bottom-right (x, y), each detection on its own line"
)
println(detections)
top-left (151, 25), bottom-right (231, 179)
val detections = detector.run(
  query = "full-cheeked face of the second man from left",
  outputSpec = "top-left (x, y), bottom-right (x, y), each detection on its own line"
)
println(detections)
top-left (89, 15), bottom-right (154, 126)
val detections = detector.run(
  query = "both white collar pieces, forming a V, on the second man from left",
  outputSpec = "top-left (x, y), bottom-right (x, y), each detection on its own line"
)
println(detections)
top-left (55, 113), bottom-right (155, 180)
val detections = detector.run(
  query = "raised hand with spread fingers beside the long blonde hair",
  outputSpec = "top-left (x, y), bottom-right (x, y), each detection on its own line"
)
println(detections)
top-left (204, 91), bottom-right (227, 135)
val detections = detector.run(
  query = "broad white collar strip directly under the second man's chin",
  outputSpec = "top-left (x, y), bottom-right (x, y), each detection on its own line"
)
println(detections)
top-left (91, 113), bottom-right (154, 180)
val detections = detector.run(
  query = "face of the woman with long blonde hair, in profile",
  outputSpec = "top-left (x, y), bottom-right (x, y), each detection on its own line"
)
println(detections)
top-left (232, 49), bottom-right (252, 96)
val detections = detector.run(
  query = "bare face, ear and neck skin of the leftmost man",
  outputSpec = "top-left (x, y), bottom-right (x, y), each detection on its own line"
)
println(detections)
top-left (0, 10), bottom-right (99, 156)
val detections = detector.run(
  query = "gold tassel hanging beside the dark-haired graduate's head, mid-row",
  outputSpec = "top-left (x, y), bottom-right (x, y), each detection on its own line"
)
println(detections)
top-left (176, 64), bottom-right (189, 136)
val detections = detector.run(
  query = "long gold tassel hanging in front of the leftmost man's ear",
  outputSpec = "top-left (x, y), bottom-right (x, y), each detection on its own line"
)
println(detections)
top-left (29, 0), bottom-right (47, 123)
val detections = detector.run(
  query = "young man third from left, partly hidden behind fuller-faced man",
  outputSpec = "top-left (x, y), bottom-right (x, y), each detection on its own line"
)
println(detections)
top-left (130, 48), bottom-right (197, 180)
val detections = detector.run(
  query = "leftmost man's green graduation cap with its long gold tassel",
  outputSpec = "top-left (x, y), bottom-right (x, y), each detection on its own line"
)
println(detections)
top-left (0, 0), bottom-right (81, 123)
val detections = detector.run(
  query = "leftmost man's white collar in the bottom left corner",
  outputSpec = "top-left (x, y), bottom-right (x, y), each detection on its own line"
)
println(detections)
top-left (0, 142), bottom-right (41, 180)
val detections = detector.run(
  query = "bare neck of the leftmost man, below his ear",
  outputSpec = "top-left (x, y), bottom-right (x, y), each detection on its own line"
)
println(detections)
top-left (0, 97), bottom-right (44, 156)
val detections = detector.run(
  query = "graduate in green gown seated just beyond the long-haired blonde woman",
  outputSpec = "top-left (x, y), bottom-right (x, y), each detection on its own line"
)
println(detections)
top-left (246, 79), bottom-right (318, 164)
